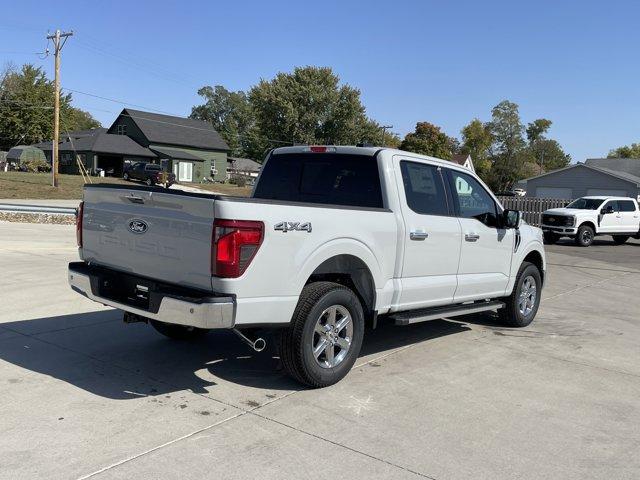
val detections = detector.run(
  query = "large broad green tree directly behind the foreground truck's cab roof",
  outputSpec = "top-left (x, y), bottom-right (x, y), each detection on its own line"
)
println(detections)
top-left (249, 67), bottom-right (381, 146)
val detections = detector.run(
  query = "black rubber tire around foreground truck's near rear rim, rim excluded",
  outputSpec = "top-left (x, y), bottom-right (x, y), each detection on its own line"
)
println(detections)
top-left (280, 282), bottom-right (364, 388)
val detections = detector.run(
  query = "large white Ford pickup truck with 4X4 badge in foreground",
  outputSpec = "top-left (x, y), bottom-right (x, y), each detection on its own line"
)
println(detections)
top-left (68, 146), bottom-right (545, 387)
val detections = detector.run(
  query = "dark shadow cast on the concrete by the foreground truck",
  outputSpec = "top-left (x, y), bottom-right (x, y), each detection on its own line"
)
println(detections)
top-left (0, 310), bottom-right (469, 399)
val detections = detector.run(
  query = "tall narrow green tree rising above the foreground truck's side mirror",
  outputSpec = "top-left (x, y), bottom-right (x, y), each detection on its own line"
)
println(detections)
top-left (488, 100), bottom-right (526, 191)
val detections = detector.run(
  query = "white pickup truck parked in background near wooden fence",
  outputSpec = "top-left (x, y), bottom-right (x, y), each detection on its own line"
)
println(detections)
top-left (542, 197), bottom-right (640, 247)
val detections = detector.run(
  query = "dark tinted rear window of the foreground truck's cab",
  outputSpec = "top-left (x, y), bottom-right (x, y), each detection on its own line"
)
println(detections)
top-left (253, 153), bottom-right (383, 208)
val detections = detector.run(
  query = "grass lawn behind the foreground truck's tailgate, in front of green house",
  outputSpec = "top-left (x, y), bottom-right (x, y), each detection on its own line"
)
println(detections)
top-left (0, 172), bottom-right (251, 200)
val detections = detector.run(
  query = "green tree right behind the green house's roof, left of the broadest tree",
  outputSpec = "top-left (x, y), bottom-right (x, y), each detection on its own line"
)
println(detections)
top-left (191, 85), bottom-right (267, 160)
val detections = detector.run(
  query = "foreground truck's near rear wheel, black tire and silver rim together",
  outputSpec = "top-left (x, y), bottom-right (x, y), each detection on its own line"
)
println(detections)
top-left (280, 282), bottom-right (364, 387)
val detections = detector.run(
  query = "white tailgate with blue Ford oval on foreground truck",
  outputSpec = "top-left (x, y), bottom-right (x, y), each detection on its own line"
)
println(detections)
top-left (81, 185), bottom-right (215, 291)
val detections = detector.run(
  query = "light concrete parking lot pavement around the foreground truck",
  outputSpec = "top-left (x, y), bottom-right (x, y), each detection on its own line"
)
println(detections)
top-left (0, 223), bottom-right (640, 480)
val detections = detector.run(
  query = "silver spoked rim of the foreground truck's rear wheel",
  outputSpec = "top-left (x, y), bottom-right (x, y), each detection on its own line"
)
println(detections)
top-left (311, 305), bottom-right (353, 368)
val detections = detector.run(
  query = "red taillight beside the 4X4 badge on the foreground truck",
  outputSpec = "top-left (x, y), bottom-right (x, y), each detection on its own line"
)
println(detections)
top-left (211, 219), bottom-right (264, 278)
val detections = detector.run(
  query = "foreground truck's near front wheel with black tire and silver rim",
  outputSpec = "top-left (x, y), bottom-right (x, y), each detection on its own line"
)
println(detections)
top-left (498, 262), bottom-right (542, 327)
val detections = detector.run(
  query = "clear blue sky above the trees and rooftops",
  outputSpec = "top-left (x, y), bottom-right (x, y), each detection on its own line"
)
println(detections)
top-left (0, 0), bottom-right (640, 161)
